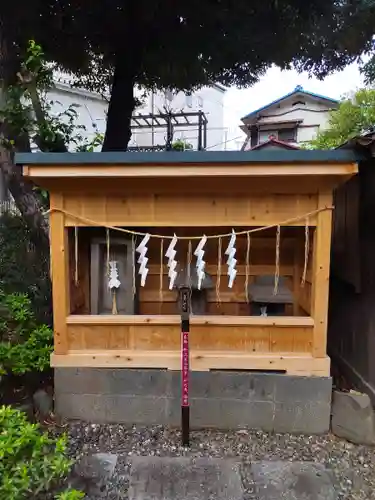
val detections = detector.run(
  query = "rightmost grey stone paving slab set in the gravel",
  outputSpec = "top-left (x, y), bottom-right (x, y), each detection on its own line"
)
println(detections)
top-left (253, 461), bottom-right (337, 500)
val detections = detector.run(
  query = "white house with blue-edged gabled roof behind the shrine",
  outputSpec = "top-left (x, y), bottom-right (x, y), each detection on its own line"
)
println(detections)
top-left (241, 86), bottom-right (338, 151)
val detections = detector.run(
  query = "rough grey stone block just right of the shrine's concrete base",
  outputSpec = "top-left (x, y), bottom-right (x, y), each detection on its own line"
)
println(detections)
top-left (332, 391), bottom-right (375, 445)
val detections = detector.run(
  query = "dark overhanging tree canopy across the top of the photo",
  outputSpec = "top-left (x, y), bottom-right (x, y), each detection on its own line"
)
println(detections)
top-left (53, 0), bottom-right (375, 90)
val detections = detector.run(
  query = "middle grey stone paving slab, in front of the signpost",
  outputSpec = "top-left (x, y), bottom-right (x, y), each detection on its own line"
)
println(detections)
top-left (129, 457), bottom-right (244, 500)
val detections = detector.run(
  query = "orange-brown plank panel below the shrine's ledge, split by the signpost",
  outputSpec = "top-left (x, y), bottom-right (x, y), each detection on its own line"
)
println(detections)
top-left (67, 324), bottom-right (313, 353)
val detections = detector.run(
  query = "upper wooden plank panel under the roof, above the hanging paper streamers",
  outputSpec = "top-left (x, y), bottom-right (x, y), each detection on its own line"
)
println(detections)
top-left (64, 191), bottom-right (317, 227)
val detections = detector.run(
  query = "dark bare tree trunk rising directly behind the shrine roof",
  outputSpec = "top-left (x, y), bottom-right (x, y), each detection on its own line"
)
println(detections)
top-left (102, 50), bottom-right (137, 151)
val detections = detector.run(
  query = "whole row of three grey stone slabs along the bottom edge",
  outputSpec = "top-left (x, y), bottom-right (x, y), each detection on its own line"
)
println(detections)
top-left (73, 453), bottom-right (337, 500)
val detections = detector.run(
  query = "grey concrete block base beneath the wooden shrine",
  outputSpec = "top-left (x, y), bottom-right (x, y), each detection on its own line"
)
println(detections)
top-left (55, 368), bottom-right (332, 434)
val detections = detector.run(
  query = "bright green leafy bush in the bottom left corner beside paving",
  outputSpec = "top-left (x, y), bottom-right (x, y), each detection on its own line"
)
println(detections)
top-left (0, 406), bottom-right (75, 500)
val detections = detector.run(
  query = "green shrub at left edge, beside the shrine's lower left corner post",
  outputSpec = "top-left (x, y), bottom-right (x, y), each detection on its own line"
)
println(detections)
top-left (0, 293), bottom-right (53, 375)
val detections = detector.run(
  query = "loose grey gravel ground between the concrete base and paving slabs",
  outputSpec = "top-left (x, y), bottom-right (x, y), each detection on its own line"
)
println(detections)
top-left (62, 423), bottom-right (375, 500)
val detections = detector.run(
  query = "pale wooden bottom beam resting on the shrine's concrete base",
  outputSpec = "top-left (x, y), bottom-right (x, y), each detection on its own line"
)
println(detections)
top-left (51, 350), bottom-right (330, 376)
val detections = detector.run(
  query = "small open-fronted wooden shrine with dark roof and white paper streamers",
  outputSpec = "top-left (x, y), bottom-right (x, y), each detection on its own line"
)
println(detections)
top-left (17, 150), bottom-right (357, 376)
